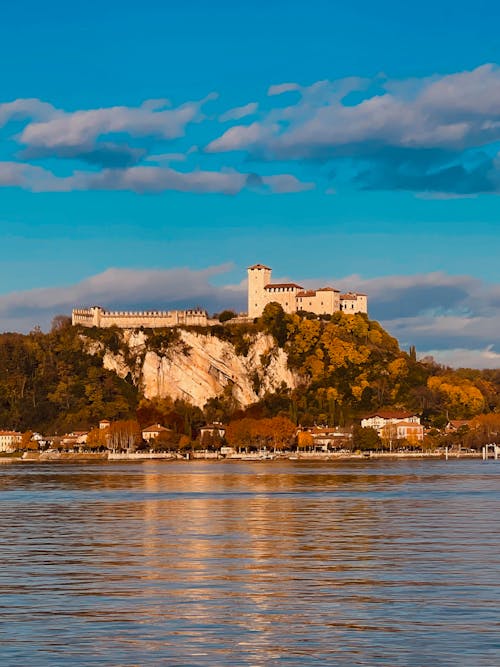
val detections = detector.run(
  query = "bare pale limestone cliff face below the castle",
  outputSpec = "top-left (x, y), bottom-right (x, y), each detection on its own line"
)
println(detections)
top-left (98, 329), bottom-right (299, 408)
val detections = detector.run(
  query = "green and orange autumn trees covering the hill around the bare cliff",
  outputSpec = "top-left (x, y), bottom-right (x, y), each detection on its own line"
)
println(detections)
top-left (0, 304), bottom-right (500, 436)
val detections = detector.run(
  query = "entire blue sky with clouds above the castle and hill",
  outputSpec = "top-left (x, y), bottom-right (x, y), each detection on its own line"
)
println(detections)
top-left (0, 0), bottom-right (500, 368)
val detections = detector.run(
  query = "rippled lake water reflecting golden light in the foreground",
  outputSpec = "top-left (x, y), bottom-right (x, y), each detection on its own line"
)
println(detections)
top-left (0, 461), bottom-right (500, 667)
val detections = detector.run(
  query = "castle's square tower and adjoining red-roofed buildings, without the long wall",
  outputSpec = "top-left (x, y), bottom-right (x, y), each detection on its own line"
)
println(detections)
top-left (248, 264), bottom-right (368, 318)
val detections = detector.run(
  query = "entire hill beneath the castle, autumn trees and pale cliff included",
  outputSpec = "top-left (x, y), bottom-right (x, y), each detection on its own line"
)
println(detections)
top-left (0, 304), bottom-right (500, 433)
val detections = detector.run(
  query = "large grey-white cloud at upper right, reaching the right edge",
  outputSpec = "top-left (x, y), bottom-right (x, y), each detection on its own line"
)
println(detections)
top-left (212, 65), bottom-right (500, 158)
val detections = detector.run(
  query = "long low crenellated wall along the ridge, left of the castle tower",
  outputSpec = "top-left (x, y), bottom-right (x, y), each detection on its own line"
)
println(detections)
top-left (71, 306), bottom-right (210, 329)
